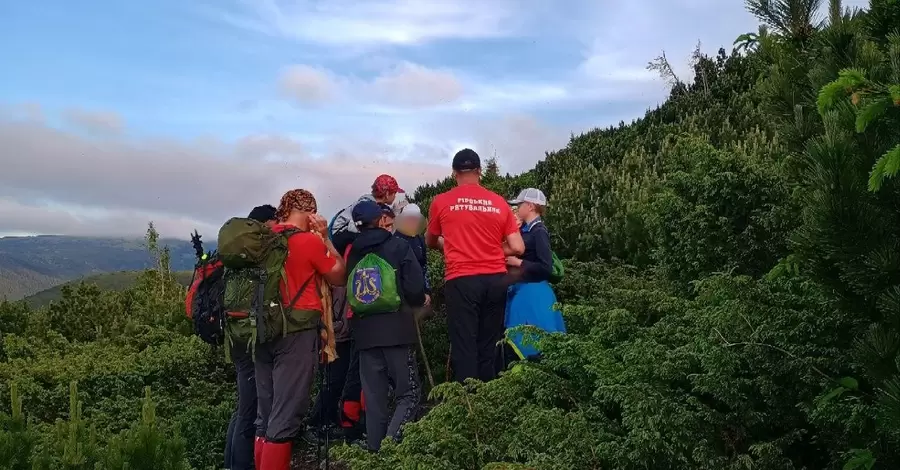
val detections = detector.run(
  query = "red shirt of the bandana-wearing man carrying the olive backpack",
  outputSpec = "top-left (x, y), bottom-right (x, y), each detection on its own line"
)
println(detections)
top-left (272, 224), bottom-right (337, 312)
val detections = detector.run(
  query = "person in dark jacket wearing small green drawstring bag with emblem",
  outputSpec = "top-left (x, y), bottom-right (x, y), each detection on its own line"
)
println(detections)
top-left (347, 201), bottom-right (425, 452)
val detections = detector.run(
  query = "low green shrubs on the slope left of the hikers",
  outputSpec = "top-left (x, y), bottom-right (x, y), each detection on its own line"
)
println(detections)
top-left (0, 228), bottom-right (235, 470)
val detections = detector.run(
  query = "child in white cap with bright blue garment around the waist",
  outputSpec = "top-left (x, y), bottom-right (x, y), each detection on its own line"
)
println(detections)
top-left (503, 188), bottom-right (566, 363)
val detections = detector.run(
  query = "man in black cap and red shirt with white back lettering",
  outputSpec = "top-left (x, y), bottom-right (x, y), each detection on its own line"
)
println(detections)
top-left (425, 149), bottom-right (525, 382)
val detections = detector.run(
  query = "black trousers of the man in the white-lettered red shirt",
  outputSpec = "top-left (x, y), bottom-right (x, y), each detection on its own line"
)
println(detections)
top-left (444, 274), bottom-right (508, 382)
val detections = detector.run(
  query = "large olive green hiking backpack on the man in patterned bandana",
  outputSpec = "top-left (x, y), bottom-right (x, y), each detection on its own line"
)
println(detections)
top-left (217, 217), bottom-right (309, 358)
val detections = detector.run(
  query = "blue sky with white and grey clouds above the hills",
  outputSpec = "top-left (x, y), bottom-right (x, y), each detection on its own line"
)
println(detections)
top-left (0, 0), bottom-right (861, 236)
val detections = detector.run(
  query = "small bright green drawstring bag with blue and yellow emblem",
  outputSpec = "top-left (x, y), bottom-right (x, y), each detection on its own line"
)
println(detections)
top-left (347, 253), bottom-right (400, 317)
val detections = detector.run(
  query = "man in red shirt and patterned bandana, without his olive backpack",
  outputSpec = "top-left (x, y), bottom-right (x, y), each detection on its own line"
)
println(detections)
top-left (254, 189), bottom-right (346, 470)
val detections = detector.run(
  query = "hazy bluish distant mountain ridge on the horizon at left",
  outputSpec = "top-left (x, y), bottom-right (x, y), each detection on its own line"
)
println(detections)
top-left (0, 235), bottom-right (215, 300)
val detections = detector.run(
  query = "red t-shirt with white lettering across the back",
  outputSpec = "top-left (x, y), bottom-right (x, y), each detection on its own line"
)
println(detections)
top-left (428, 184), bottom-right (519, 280)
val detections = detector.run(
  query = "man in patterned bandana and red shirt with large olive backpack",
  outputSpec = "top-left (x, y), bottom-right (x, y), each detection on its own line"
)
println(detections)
top-left (217, 189), bottom-right (346, 470)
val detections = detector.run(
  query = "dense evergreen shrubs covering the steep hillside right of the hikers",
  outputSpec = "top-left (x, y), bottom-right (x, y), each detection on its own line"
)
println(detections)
top-left (340, 0), bottom-right (900, 469)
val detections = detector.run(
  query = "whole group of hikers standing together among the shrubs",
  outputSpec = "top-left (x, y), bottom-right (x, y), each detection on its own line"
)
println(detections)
top-left (186, 149), bottom-right (565, 470)
